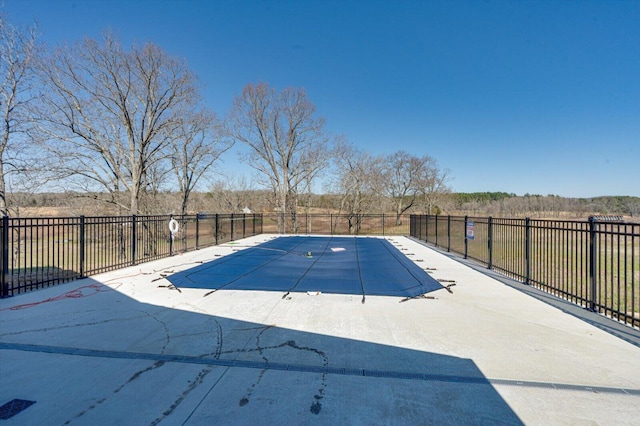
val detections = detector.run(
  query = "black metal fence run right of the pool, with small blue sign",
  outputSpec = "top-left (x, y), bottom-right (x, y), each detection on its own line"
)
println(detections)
top-left (410, 215), bottom-right (640, 328)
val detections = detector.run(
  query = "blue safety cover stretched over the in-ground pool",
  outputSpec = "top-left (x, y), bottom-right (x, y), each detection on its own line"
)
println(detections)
top-left (167, 236), bottom-right (443, 297)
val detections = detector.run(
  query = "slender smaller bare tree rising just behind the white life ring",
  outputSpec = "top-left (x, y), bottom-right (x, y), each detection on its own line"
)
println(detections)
top-left (169, 111), bottom-right (233, 215)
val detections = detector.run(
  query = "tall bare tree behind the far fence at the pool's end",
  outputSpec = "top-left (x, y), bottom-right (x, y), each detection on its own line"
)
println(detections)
top-left (229, 83), bottom-right (330, 233)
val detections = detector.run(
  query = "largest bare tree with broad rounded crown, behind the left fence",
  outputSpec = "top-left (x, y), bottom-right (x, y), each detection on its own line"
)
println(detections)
top-left (39, 34), bottom-right (205, 214)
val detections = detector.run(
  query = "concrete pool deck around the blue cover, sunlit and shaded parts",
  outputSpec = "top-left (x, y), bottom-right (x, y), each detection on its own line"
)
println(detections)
top-left (0, 235), bottom-right (640, 425)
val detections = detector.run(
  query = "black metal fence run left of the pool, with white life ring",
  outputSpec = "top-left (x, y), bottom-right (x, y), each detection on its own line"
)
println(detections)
top-left (0, 214), bottom-right (262, 297)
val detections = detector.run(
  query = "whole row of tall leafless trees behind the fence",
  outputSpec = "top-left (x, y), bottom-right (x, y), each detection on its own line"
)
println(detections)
top-left (0, 15), bottom-right (449, 231)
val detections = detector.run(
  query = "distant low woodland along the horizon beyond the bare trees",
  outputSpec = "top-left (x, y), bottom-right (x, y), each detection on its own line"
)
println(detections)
top-left (13, 190), bottom-right (640, 223)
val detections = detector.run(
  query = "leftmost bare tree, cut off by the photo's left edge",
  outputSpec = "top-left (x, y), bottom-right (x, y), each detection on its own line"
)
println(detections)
top-left (0, 14), bottom-right (37, 215)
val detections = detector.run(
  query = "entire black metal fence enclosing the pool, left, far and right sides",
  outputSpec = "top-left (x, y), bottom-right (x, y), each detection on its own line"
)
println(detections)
top-left (0, 214), bottom-right (640, 328)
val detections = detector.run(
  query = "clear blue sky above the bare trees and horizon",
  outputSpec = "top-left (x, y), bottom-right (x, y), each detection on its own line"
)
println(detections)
top-left (0, 0), bottom-right (640, 197)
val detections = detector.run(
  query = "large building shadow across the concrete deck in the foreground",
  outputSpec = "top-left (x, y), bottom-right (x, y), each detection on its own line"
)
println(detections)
top-left (0, 279), bottom-right (522, 425)
